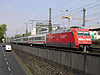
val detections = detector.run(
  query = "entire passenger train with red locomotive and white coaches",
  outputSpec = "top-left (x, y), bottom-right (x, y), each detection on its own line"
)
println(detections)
top-left (11, 27), bottom-right (92, 52)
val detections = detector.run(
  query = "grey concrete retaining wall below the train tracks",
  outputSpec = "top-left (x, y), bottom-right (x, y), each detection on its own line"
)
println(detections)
top-left (12, 44), bottom-right (100, 75)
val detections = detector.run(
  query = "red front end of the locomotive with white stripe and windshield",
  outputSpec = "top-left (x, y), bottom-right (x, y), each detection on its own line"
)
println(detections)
top-left (77, 29), bottom-right (92, 52)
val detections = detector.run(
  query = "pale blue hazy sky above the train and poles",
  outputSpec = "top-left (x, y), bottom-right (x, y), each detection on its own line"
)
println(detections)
top-left (0, 0), bottom-right (100, 37)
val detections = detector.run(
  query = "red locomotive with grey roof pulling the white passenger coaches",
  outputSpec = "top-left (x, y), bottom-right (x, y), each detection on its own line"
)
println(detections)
top-left (46, 28), bottom-right (92, 50)
